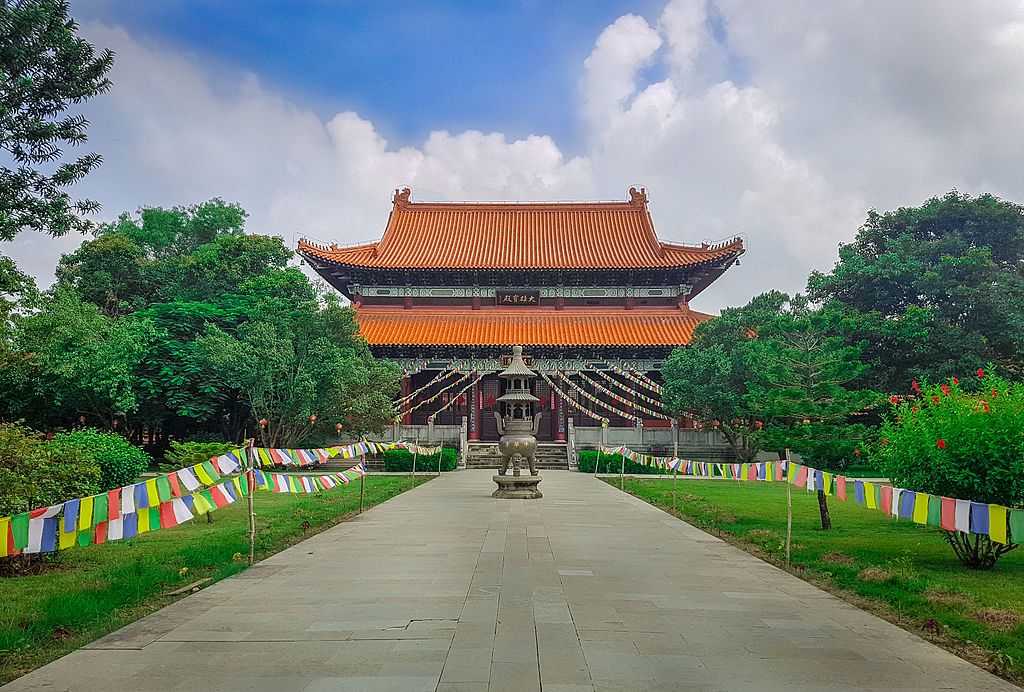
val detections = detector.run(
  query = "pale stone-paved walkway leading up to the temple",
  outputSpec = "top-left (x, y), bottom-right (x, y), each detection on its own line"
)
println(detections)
top-left (4, 471), bottom-right (1018, 692)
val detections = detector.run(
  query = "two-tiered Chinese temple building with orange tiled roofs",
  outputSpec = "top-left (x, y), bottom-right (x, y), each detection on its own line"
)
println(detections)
top-left (298, 187), bottom-right (743, 462)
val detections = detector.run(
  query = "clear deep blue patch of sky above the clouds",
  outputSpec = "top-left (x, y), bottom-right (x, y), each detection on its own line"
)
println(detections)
top-left (74, 0), bottom-right (664, 153)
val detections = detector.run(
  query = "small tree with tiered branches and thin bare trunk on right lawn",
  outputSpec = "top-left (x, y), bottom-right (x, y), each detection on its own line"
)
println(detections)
top-left (744, 296), bottom-right (882, 529)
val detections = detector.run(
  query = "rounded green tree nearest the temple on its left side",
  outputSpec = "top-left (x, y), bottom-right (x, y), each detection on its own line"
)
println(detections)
top-left (199, 296), bottom-right (399, 446)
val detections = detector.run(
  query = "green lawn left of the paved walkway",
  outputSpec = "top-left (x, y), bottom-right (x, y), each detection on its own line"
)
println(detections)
top-left (0, 476), bottom-right (429, 684)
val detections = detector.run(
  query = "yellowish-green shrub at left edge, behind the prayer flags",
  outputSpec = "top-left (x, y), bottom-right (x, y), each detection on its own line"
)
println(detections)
top-left (0, 425), bottom-right (101, 516)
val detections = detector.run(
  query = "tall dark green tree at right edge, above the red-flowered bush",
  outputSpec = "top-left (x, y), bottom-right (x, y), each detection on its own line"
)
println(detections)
top-left (808, 190), bottom-right (1024, 392)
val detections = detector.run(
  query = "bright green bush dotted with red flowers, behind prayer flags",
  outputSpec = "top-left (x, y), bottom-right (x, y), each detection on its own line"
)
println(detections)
top-left (874, 370), bottom-right (1024, 566)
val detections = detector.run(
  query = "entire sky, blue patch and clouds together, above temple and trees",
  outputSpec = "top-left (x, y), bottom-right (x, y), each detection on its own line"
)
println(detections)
top-left (9, 0), bottom-right (1024, 311)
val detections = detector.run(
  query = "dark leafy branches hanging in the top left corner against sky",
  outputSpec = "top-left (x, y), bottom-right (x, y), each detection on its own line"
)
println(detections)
top-left (0, 0), bottom-right (114, 241)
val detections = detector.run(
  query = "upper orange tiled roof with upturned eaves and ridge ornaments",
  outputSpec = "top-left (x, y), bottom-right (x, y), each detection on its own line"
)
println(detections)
top-left (299, 187), bottom-right (743, 269)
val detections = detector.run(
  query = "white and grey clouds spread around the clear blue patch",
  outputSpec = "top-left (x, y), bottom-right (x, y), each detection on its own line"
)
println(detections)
top-left (2, 0), bottom-right (1024, 309)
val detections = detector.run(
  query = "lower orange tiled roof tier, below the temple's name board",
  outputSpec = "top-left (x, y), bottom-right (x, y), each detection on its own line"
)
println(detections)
top-left (356, 307), bottom-right (711, 346)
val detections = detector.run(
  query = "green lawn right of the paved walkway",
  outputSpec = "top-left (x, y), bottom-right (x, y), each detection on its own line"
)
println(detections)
top-left (607, 478), bottom-right (1024, 683)
